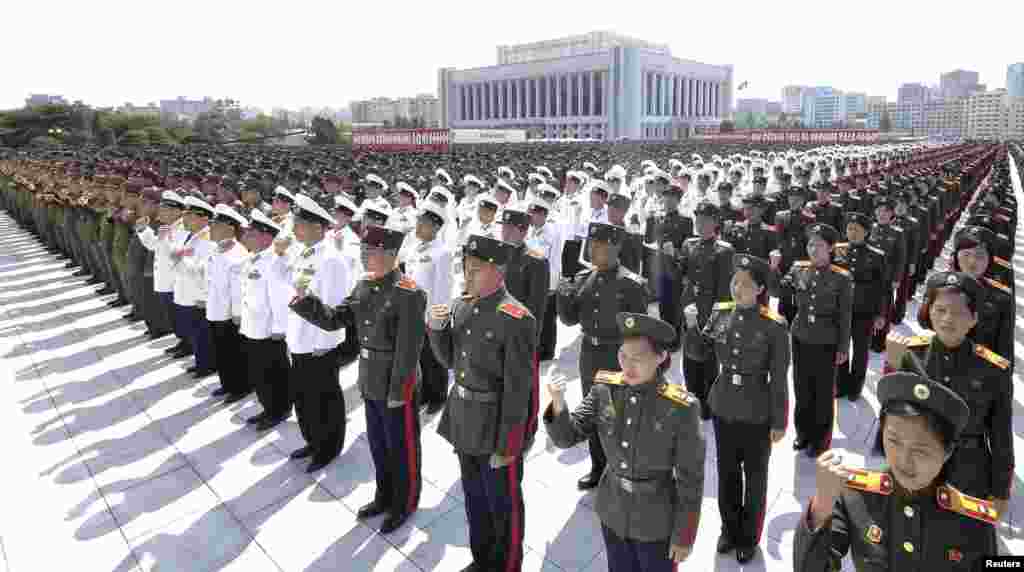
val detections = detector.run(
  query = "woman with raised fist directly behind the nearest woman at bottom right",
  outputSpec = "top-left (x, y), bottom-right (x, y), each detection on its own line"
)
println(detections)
top-left (888, 272), bottom-right (1014, 519)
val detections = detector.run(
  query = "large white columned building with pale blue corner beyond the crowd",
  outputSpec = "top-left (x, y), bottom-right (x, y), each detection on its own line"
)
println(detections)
top-left (437, 32), bottom-right (733, 140)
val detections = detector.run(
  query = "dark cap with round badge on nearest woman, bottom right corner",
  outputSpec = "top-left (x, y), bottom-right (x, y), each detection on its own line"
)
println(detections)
top-left (877, 371), bottom-right (971, 439)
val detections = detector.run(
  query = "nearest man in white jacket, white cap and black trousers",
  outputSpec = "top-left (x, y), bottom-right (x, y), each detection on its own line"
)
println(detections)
top-left (278, 194), bottom-right (352, 473)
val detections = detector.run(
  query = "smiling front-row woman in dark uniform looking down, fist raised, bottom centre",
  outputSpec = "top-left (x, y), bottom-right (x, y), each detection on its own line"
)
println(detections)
top-left (544, 312), bottom-right (705, 572)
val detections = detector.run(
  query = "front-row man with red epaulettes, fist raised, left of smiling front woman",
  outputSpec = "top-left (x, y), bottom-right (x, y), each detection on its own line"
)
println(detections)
top-left (430, 234), bottom-right (539, 572)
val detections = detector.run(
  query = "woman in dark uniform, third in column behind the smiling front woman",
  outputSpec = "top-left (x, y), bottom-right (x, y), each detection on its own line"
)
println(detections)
top-left (778, 223), bottom-right (853, 457)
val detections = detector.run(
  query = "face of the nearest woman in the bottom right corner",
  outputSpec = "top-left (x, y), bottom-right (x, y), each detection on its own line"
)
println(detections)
top-left (882, 414), bottom-right (951, 491)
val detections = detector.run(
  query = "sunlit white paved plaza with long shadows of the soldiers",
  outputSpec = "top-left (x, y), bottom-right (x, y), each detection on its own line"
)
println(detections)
top-left (0, 160), bottom-right (1024, 572)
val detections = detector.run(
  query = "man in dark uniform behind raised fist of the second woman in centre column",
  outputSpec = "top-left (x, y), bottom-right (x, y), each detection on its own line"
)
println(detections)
top-left (676, 202), bottom-right (735, 421)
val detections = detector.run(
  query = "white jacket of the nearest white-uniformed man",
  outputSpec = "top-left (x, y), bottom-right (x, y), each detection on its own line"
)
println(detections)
top-left (285, 239), bottom-right (354, 354)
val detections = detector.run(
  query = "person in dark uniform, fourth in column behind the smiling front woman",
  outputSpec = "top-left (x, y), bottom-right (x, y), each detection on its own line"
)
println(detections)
top-left (834, 212), bottom-right (889, 401)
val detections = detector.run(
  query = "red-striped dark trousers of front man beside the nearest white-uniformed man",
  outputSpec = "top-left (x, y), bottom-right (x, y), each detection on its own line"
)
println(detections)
top-left (364, 399), bottom-right (423, 516)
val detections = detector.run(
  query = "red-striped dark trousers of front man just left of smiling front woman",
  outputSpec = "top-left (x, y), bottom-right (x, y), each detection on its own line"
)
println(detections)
top-left (458, 453), bottom-right (526, 572)
